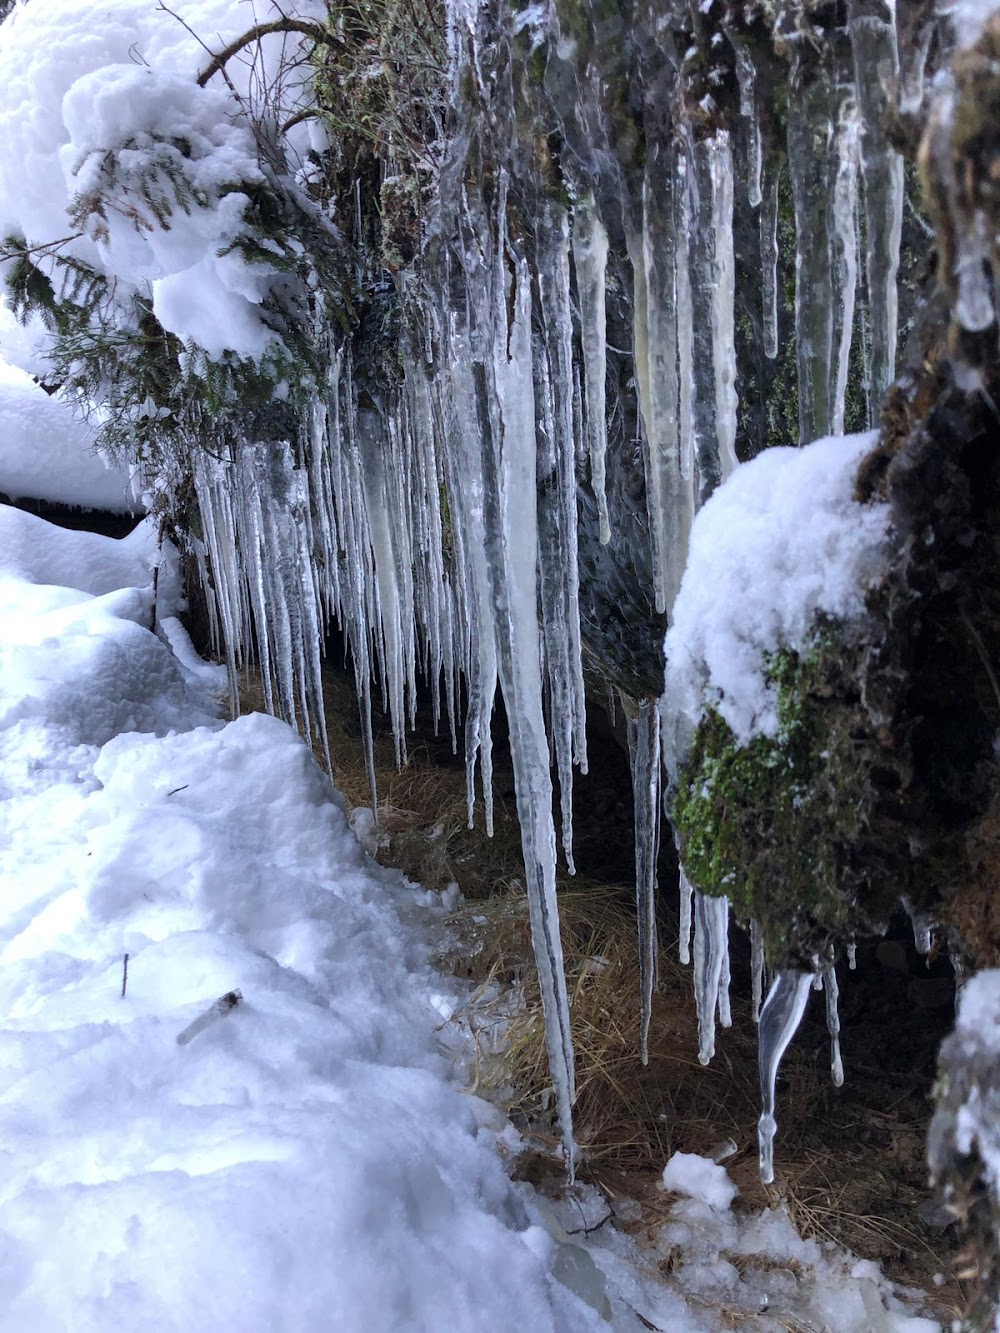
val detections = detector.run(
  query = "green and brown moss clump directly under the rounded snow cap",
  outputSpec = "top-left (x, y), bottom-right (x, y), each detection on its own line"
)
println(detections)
top-left (672, 625), bottom-right (873, 965)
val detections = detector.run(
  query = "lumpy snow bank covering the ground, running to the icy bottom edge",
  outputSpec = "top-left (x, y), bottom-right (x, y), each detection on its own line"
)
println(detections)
top-left (0, 508), bottom-right (936, 1333)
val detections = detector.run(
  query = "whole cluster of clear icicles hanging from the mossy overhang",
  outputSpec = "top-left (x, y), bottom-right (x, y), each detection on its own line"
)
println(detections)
top-left (188, 0), bottom-right (949, 1180)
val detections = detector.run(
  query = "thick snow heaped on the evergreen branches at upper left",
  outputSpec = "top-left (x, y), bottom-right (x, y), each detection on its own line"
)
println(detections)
top-left (0, 0), bottom-right (321, 359)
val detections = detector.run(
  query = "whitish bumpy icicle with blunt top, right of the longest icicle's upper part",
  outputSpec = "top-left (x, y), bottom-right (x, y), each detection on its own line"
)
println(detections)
top-left (573, 195), bottom-right (611, 545)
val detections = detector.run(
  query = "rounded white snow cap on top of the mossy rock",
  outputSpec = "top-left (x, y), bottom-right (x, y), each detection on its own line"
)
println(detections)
top-left (664, 432), bottom-right (888, 765)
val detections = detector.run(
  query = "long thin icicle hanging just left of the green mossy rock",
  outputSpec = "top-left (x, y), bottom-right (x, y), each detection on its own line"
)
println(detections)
top-left (628, 698), bottom-right (660, 1065)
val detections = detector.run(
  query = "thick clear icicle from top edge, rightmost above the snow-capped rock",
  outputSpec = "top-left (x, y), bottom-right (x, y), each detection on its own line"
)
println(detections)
top-left (847, 0), bottom-right (904, 410)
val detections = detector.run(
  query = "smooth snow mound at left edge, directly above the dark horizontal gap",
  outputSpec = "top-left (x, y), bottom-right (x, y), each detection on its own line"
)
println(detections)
top-left (0, 359), bottom-right (133, 512)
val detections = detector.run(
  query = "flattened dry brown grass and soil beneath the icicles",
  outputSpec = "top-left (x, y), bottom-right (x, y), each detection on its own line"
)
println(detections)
top-left (234, 670), bottom-right (965, 1318)
